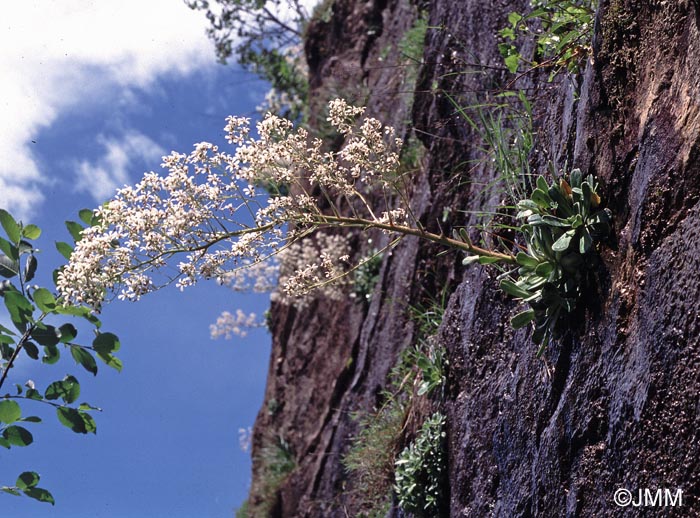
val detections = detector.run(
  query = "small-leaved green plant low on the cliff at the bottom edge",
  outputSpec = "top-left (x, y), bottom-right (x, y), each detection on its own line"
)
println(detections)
top-left (394, 412), bottom-right (447, 517)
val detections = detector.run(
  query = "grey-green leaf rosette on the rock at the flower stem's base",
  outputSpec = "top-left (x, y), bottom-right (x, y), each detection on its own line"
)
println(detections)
top-left (492, 173), bottom-right (612, 355)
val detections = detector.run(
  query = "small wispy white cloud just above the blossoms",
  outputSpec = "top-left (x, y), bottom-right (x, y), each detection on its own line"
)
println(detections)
top-left (77, 130), bottom-right (165, 203)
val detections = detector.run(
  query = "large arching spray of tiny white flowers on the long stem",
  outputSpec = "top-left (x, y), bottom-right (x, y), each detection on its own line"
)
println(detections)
top-left (58, 99), bottom-right (406, 308)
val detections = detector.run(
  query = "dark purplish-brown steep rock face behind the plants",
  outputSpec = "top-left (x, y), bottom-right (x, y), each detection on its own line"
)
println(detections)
top-left (246, 0), bottom-right (700, 517)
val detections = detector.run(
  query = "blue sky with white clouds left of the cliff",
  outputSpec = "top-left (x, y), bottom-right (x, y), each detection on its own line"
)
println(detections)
top-left (0, 0), bottom-right (270, 518)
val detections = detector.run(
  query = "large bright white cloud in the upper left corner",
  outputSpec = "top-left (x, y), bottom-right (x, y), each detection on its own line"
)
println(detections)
top-left (0, 0), bottom-right (216, 216)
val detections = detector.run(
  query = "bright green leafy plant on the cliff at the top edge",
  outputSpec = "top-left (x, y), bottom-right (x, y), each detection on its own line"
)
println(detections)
top-left (498, 0), bottom-right (597, 80)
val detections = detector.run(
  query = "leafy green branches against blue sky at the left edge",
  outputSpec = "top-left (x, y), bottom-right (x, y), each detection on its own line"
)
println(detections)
top-left (0, 209), bottom-right (121, 504)
